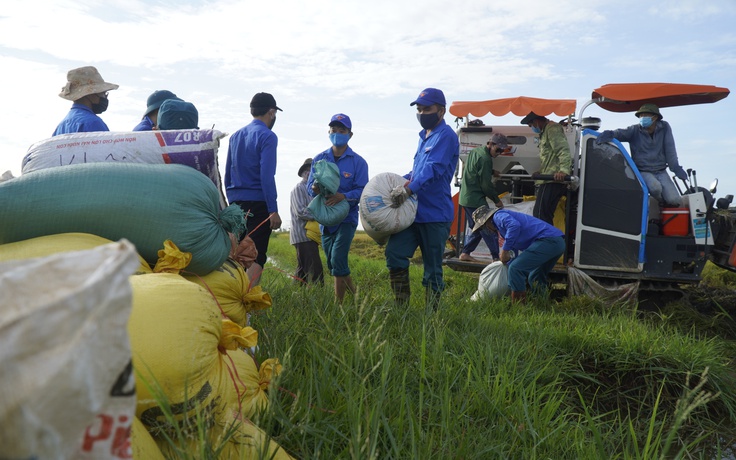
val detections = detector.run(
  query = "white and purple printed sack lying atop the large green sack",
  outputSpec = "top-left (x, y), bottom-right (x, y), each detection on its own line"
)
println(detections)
top-left (21, 129), bottom-right (227, 205)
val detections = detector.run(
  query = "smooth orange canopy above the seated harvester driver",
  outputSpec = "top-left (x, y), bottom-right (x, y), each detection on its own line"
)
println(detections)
top-left (592, 83), bottom-right (729, 112)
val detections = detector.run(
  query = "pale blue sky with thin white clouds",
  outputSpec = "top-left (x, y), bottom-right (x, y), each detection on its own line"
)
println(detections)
top-left (0, 0), bottom-right (736, 225)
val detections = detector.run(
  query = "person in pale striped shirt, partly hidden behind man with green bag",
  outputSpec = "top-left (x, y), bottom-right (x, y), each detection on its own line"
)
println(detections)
top-left (289, 158), bottom-right (324, 285)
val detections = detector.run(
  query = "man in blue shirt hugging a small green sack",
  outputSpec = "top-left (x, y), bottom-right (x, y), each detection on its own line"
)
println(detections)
top-left (307, 113), bottom-right (368, 302)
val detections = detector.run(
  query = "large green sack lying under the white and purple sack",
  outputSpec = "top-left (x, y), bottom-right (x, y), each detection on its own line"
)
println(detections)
top-left (0, 163), bottom-right (244, 275)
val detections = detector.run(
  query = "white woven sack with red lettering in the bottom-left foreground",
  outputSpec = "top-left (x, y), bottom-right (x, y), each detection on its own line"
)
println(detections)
top-left (0, 240), bottom-right (140, 459)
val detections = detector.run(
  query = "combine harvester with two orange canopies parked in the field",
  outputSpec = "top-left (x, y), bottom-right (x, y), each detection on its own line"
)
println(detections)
top-left (445, 83), bottom-right (736, 293)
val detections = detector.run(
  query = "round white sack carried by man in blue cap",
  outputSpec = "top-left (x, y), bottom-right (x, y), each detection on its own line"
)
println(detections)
top-left (360, 173), bottom-right (417, 245)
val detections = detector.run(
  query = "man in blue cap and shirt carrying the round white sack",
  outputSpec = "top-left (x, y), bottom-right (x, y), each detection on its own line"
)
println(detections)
top-left (386, 88), bottom-right (460, 312)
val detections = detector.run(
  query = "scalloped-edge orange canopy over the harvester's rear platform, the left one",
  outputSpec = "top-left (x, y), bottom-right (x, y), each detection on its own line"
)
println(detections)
top-left (450, 96), bottom-right (576, 117)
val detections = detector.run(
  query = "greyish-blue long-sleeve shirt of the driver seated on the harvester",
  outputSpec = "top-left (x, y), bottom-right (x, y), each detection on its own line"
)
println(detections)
top-left (613, 120), bottom-right (686, 177)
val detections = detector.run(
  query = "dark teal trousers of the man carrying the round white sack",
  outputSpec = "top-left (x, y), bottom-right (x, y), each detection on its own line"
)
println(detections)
top-left (385, 222), bottom-right (452, 291)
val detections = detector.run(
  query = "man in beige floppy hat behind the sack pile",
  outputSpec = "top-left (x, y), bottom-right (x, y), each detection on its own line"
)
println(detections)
top-left (52, 66), bottom-right (118, 136)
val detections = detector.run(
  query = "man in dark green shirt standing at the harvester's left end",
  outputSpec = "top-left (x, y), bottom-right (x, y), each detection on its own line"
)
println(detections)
top-left (458, 133), bottom-right (508, 262)
